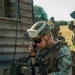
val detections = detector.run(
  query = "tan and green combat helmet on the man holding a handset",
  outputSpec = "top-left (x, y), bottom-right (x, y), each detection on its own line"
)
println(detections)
top-left (25, 21), bottom-right (51, 39)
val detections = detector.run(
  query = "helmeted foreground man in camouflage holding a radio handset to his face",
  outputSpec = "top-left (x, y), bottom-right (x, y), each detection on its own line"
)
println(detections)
top-left (26, 21), bottom-right (72, 75)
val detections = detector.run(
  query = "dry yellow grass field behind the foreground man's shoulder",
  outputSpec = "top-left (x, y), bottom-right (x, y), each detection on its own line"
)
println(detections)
top-left (60, 26), bottom-right (75, 51)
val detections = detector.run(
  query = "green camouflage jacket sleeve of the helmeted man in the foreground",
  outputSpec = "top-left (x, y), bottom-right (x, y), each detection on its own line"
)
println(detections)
top-left (53, 46), bottom-right (72, 75)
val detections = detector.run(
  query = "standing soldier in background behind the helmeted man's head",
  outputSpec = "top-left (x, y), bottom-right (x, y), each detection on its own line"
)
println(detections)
top-left (49, 17), bottom-right (60, 41)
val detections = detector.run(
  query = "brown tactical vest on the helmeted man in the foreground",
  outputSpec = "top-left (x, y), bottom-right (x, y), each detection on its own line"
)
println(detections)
top-left (43, 47), bottom-right (59, 73)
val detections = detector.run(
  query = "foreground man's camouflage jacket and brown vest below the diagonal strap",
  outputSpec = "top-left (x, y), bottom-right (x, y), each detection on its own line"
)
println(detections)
top-left (37, 45), bottom-right (72, 75)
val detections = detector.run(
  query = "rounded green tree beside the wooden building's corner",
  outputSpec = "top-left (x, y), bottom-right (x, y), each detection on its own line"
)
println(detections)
top-left (34, 5), bottom-right (48, 22)
